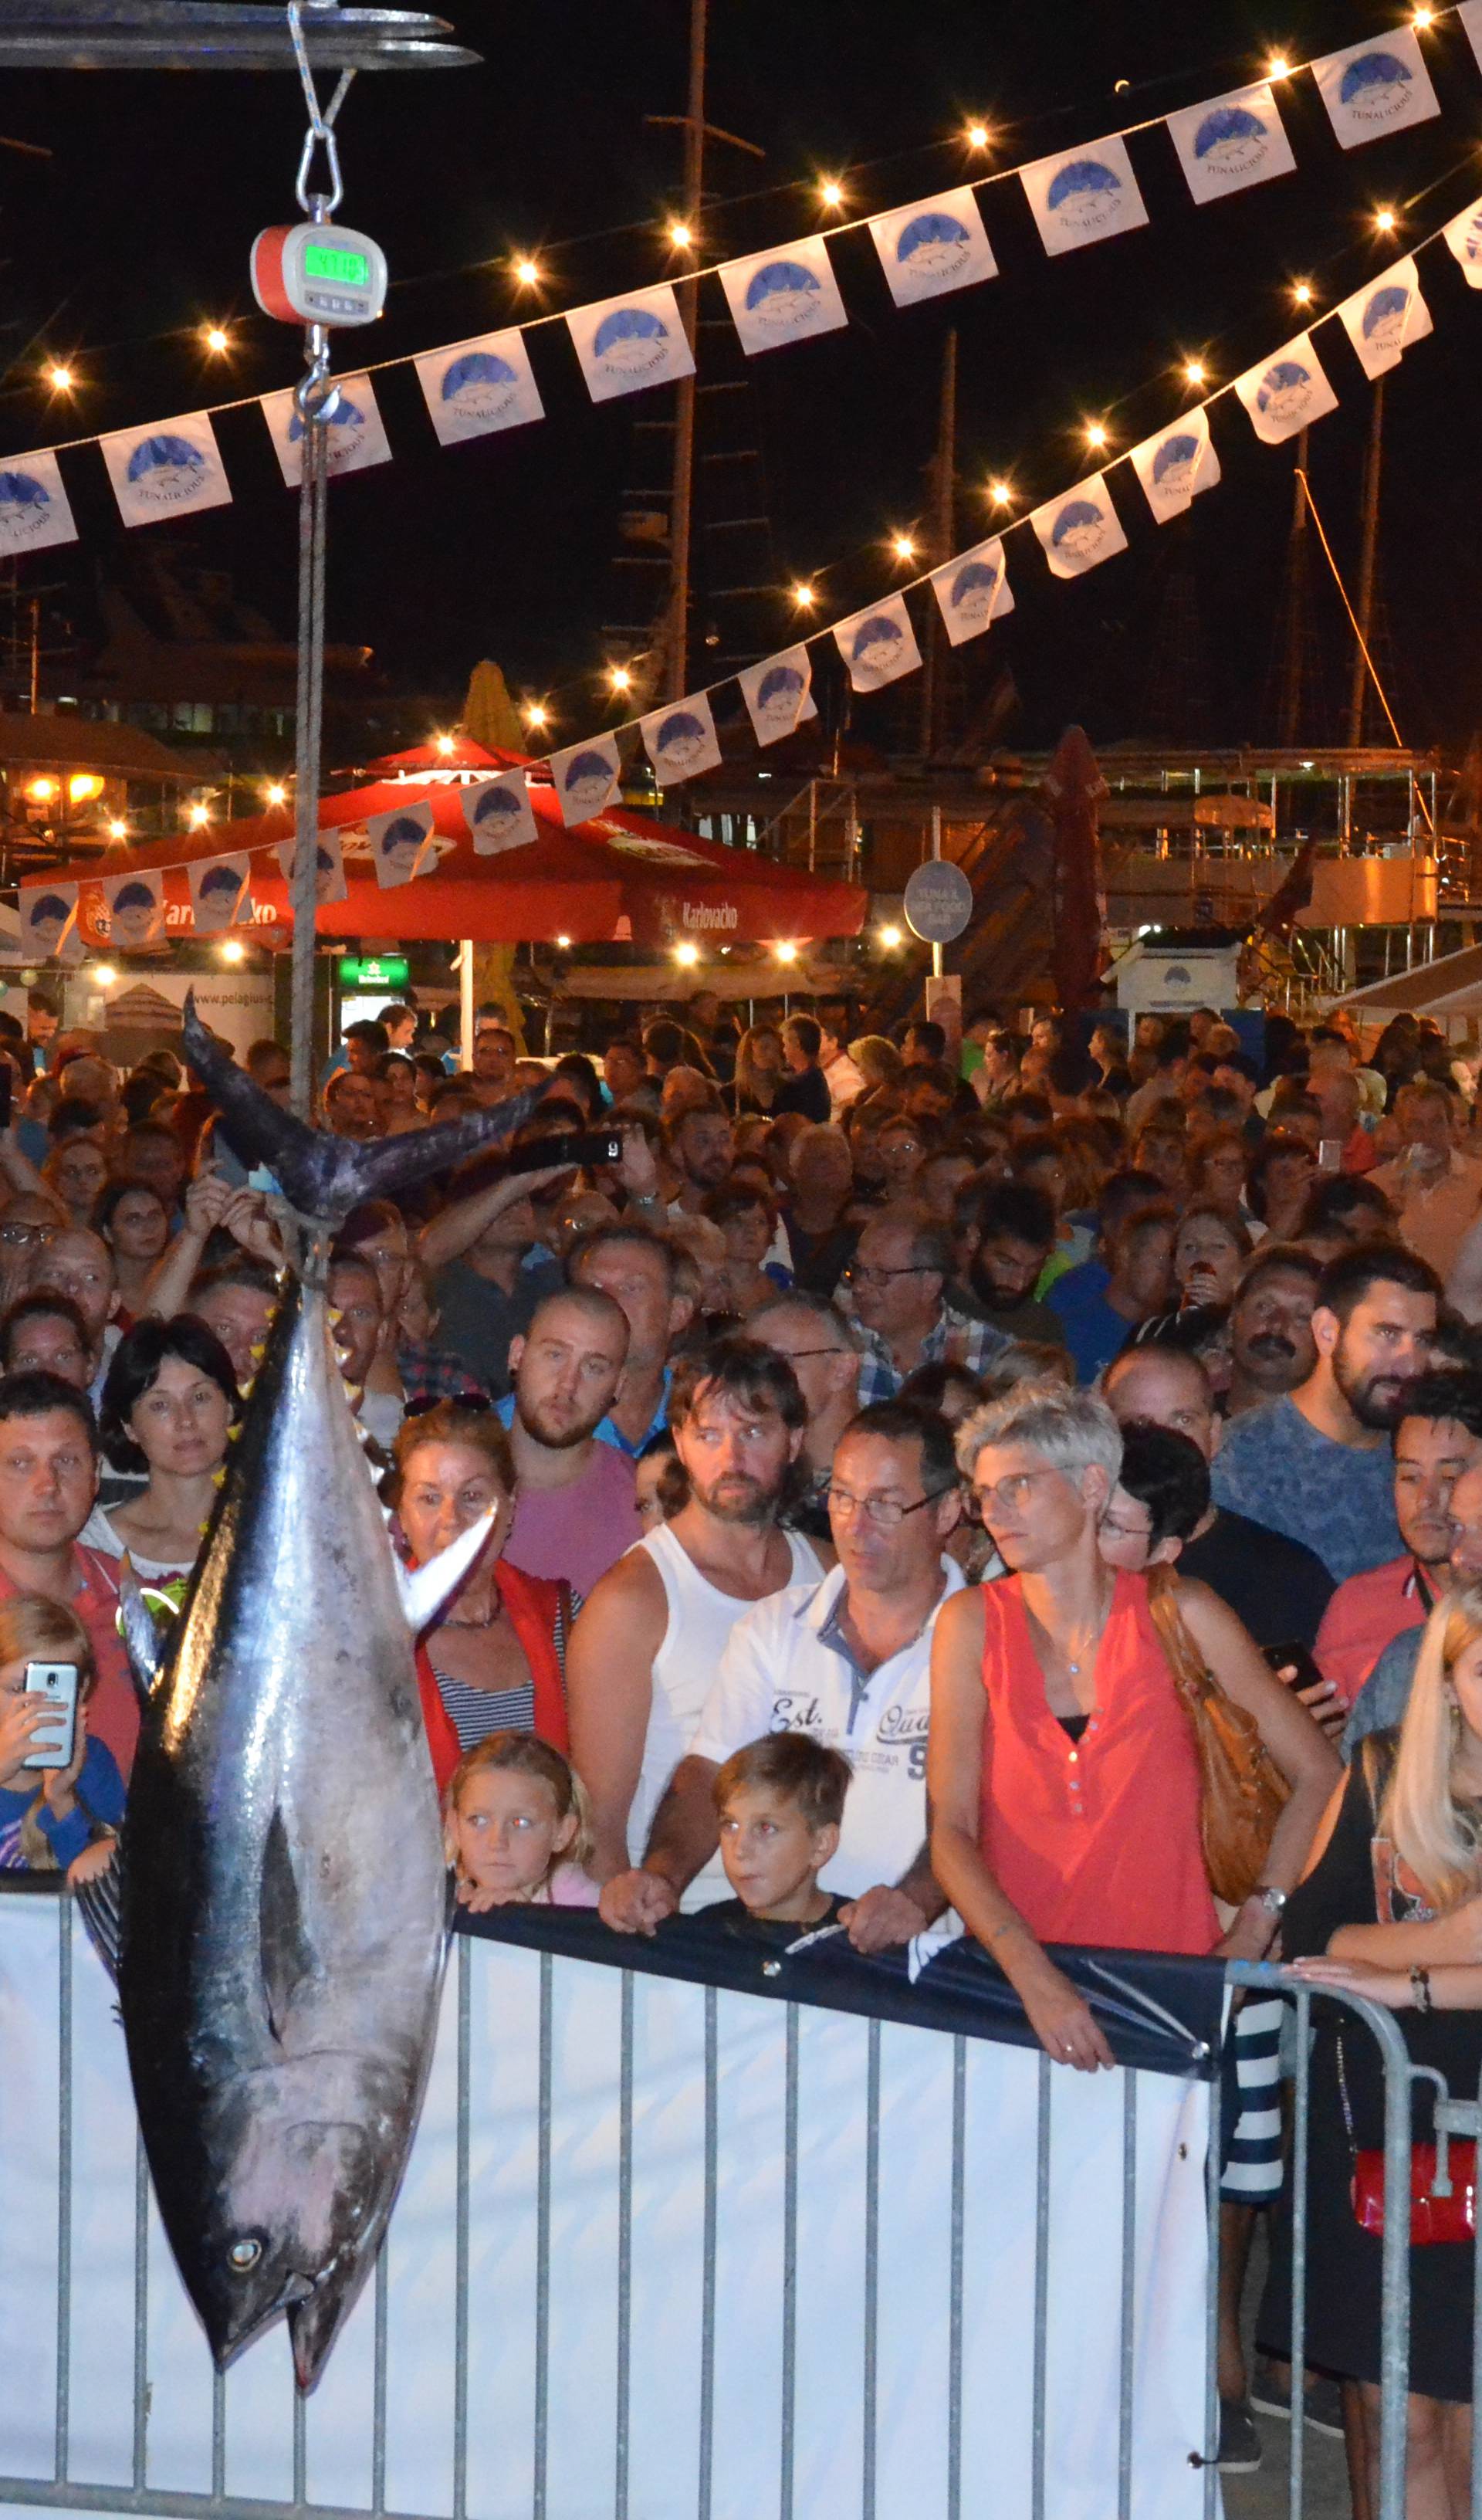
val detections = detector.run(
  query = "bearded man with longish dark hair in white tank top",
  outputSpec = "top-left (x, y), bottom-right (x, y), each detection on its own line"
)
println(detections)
top-left (567, 1338), bottom-right (829, 1932)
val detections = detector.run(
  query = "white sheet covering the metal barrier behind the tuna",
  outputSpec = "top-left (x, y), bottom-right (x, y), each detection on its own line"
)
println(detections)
top-left (0, 1898), bottom-right (1207, 2520)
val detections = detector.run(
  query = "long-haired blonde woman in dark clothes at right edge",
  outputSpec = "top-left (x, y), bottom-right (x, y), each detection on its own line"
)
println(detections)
top-left (1260, 1585), bottom-right (1482, 2520)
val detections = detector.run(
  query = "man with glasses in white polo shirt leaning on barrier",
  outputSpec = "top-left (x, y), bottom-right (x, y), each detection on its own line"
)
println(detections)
top-left (602, 1401), bottom-right (963, 1950)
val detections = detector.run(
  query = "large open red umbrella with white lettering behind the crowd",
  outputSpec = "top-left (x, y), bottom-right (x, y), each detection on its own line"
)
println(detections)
top-left (48, 754), bottom-right (867, 945)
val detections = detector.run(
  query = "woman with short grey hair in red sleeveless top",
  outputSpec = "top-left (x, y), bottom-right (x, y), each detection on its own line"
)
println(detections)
top-left (928, 1388), bottom-right (1323, 2071)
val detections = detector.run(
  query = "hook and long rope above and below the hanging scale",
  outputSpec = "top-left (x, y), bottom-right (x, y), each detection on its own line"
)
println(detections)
top-left (287, 0), bottom-right (355, 1119)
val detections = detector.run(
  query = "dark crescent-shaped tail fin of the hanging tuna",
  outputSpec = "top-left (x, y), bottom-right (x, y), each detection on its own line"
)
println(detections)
top-left (184, 993), bottom-right (544, 1224)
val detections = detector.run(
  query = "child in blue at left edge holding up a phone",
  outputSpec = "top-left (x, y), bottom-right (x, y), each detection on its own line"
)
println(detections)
top-left (0, 1593), bottom-right (124, 1888)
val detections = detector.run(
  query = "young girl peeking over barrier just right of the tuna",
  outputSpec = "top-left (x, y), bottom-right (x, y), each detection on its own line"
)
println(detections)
top-left (444, 1731), bottom-right (597, 1915)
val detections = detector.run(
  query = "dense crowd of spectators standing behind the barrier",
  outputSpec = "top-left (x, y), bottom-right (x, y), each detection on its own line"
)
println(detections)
top-left (0, 993), bottom-right (1482, 2520)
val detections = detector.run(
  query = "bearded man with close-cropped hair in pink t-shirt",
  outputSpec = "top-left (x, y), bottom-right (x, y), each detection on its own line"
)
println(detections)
top-left (496, 1285), bottom-right (643, 1593)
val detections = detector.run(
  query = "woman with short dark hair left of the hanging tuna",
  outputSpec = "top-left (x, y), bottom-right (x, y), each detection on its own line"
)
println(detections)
top-left (86, 1313), bottom-right (242, 1583)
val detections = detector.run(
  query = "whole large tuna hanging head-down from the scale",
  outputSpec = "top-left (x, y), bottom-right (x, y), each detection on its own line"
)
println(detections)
top-left (118, 998), bottom-right (537, 2389)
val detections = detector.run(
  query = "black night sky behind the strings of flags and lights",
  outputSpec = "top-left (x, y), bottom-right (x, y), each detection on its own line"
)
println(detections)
top-left (0, 0), bottom-right (1482, 746)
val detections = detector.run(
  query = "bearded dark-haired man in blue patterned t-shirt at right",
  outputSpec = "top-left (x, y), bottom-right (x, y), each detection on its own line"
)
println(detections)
top-left (1213, 1245), bottom-right (1442, 1583)
